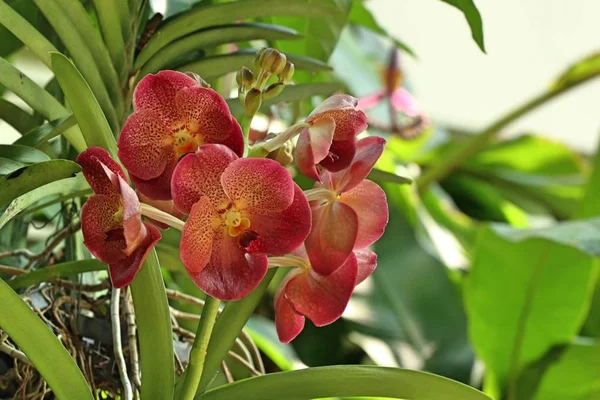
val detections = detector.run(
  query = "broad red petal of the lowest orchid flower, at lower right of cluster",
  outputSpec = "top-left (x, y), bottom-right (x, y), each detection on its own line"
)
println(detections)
top-left (284, 254), bottom-right (358, 326)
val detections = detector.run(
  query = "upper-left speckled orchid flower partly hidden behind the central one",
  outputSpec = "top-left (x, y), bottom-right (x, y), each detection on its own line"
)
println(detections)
top-left (117, 71), bottom-right (244, 200)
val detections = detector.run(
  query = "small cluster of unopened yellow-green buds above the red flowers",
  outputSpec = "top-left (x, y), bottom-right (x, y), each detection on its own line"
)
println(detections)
top-left (236, 47), bottom-right (294, 116)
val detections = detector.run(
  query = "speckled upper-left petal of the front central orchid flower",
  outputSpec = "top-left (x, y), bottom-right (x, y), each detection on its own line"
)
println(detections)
top-left (171, 144), bottom-right (238, 213)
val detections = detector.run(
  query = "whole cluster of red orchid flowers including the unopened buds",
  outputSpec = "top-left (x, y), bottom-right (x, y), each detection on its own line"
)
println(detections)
top-left (77, 49), bottom-right (388, 343)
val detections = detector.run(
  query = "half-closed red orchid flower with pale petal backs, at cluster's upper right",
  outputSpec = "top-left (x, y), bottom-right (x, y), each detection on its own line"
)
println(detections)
top-left (294, 94), bottom-right (367, 181)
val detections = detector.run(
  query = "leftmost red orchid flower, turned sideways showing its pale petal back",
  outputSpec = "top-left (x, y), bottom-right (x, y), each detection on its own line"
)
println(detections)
top-left (77, 147), bottom-right (161, 288)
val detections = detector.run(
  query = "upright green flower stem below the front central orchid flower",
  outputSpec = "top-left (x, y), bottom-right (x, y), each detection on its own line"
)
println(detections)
top-left (181, 296), bottom-right (220, 400)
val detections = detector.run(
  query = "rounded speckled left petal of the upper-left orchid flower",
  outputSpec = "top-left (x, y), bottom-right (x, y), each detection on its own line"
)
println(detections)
top-left (117, 110), bottom-right (177, 180)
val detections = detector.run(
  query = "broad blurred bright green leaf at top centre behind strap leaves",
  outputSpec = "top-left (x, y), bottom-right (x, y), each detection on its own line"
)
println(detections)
top-left (271, 0), bottom-right (352, 62)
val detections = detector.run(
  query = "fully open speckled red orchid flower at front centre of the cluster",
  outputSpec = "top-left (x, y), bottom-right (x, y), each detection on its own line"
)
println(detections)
top-left (171, 144), bottom-right (310, 300)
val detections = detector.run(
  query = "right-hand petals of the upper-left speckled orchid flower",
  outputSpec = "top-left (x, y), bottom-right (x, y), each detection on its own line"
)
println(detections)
top-left (175, 86), bottom-right (244, 157)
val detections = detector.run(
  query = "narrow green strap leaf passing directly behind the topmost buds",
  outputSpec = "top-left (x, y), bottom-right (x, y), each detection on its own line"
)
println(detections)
top-left (178, 50), bottom-right (331, 79)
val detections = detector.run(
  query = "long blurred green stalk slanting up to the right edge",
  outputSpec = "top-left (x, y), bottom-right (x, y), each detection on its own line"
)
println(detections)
top-left (416, 65), bottom-right (600, 192)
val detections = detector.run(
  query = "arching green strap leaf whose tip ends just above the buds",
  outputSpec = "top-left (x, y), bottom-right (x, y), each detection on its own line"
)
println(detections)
top-left (140, 24), bottom-right (300, 76)
